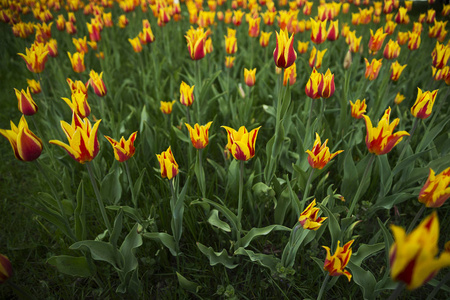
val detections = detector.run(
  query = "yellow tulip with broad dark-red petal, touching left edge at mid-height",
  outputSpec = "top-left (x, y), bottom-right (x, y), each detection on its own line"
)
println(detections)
top-left (0, 115), bottom-right (42, 161)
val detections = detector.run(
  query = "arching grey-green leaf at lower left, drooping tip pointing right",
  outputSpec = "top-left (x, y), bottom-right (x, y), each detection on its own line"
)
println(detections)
top-left (69, 240), bottom-right (123, 270)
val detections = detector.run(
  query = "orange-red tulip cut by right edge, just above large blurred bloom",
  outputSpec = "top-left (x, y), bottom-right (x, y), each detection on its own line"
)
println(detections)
top-left (419, 168), bottom-right (450, 207)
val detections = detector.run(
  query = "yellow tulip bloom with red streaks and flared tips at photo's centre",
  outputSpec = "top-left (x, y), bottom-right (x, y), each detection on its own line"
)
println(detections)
top-left (222, 126), bottom-right (261, 161)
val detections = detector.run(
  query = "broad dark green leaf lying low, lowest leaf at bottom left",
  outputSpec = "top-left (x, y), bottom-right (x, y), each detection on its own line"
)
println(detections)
top-left (47, 255), bottom-right (92, 277)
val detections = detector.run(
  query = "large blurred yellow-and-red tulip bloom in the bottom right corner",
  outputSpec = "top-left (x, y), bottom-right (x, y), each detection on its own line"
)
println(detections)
top-left (389, 211), bottom-right (450, 290)
